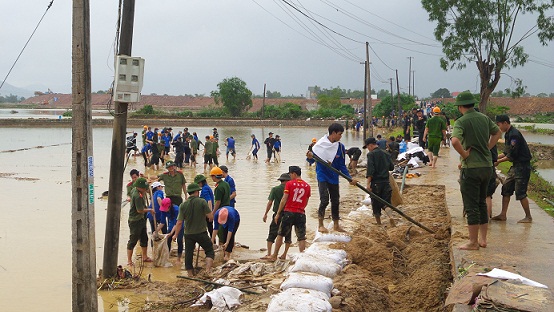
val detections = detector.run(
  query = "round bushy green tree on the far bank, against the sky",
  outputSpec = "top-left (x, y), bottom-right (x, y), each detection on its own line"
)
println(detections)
top-left (211, 77), bottom-right (252, 117)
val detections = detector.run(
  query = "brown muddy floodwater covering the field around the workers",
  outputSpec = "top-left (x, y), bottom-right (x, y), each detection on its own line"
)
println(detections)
top-left (0, 125), bottom-right (362, 311)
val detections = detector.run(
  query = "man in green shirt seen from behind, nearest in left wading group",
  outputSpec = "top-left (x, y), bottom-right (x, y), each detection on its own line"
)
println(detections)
top-left (169, 183), bottom-right (215, 276)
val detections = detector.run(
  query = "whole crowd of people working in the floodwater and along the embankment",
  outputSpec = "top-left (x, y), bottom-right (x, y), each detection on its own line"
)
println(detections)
top-left (127, 98), bottom-right (532, 275)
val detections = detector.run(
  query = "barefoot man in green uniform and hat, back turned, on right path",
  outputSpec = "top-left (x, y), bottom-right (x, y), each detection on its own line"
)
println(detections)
top-left (452, 91), bottom-right (502, 250)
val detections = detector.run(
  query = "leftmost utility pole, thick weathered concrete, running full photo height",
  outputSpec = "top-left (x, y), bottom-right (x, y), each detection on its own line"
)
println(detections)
top-left (71, 0), bottom-right (98, 312)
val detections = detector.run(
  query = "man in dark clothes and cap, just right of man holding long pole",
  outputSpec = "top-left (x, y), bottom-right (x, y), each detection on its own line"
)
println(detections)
top-left (364, 138), bottom-right (396, 227)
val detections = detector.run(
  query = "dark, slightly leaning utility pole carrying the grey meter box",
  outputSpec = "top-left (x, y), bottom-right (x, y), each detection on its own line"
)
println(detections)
top-left (102, 0), bottom-right (135, 278)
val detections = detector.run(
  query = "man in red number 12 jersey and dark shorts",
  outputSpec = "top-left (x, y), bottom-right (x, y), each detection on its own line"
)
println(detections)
top-left (269, 166), bottom-right (312, 260)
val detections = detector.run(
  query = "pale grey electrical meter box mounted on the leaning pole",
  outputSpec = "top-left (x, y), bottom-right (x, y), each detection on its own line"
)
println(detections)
top-left (113, 55), bottom-right (144, 103)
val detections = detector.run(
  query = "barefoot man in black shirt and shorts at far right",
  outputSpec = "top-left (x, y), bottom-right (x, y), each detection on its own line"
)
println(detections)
top-left (492, 115), bottom-right (533, 223)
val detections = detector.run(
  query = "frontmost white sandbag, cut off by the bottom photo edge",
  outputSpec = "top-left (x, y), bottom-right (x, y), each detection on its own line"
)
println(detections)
top-left (267, 288), bottom-right (333, 312)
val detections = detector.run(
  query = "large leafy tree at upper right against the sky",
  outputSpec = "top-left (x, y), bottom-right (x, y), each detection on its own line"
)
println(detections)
top-left (421, 0), bottom-right (554, 112)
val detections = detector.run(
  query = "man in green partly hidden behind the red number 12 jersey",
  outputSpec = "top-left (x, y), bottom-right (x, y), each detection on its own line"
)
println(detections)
top-left (262, 173), bottom-right (292, 260)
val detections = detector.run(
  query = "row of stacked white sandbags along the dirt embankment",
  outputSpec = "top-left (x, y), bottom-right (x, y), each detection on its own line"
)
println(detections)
top-left (267, 232), bottom-right (351, 312)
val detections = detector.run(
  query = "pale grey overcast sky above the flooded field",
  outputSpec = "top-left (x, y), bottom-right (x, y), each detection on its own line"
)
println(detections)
top-left (0, 0), bottom-right (554, 97)
